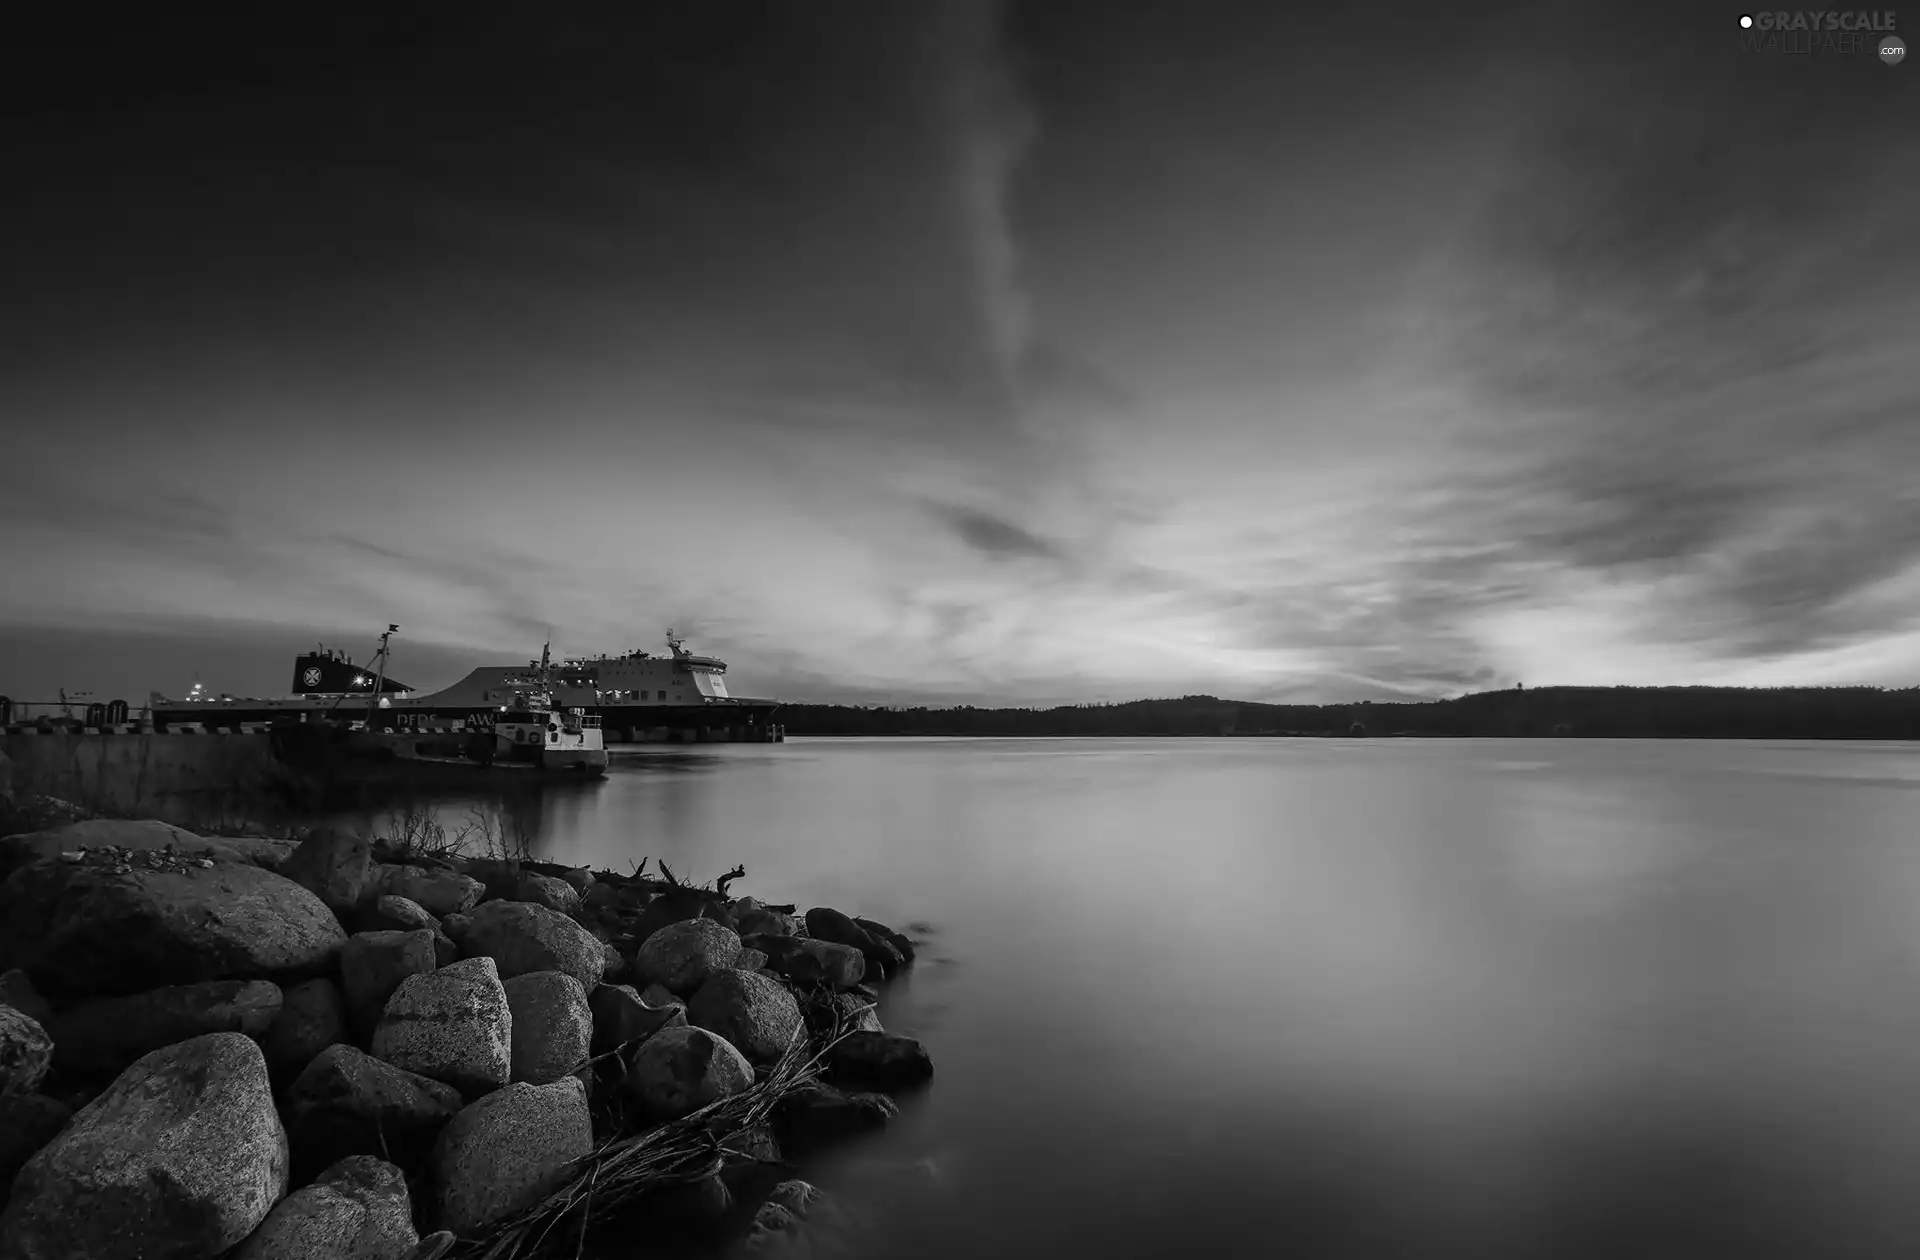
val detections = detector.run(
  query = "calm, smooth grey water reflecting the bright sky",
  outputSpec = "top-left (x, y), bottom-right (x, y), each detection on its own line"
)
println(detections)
top-left (366, 739), bottom-right (1920, 1258)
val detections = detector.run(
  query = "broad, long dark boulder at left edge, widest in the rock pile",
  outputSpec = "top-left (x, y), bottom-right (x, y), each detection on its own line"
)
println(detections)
top-left (0, 860), bottom-right (348, 1006)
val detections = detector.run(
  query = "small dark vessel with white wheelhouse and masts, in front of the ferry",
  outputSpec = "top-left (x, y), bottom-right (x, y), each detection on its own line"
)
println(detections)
top-left (273, 626), bottom-right (607, 780)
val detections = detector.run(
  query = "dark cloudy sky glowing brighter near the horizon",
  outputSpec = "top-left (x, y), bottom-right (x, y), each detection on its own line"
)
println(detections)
top-left (0, 0), bottom-right (1920, 705)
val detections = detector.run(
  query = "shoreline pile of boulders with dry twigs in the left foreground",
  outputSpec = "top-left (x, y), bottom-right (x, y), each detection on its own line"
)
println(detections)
top-left (0, 820), bottom-right (933, 1260)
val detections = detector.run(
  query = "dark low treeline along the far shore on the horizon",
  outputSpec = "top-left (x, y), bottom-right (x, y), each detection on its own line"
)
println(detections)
top-left (776, 688), bottom-right (1920, 739)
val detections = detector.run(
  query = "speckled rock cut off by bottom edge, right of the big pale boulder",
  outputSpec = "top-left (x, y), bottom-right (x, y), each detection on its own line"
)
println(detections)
top-left (228, 1154), bottom-right (420, 1260)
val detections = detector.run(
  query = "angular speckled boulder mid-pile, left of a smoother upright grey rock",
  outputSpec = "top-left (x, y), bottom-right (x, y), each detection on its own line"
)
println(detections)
top-left (372, 956), bottom-right (513, 1095)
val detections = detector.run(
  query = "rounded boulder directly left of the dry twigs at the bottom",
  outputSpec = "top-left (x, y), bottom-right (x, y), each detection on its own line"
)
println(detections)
top-left (434, 1076), bottom-right (593, 1235)
